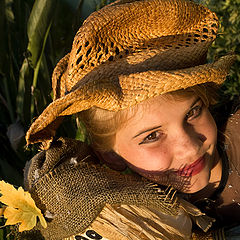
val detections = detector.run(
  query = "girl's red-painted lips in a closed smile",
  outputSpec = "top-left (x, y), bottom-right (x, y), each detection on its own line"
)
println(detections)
top-left (177, 156), bottom-right (205, 177)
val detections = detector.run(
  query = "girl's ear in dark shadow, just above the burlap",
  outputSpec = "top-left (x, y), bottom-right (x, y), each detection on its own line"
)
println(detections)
top-left (95, 151), bottom-right (127, 171)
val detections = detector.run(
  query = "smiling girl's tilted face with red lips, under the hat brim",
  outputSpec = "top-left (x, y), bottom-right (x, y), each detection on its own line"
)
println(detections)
top-left (114, 96), bottom-right (220, 193)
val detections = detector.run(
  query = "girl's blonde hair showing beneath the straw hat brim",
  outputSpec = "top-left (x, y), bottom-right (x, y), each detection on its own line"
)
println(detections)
top-left (77, 83), bottom-right (218, 152)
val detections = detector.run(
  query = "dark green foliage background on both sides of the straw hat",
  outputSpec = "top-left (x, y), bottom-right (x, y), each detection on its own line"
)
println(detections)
top-left (0, 0), bottom-right (240, 239)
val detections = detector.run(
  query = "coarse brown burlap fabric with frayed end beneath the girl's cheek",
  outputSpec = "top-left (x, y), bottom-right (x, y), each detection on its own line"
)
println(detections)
top-left (19, 139), bottom-right (180, 240)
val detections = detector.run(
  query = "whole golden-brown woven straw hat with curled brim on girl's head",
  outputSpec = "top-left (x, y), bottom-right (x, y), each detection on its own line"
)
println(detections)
top-left (26, 0), bottom-right (235, 146)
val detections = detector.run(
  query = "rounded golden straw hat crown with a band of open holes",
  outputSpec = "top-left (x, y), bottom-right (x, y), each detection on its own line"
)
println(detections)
top-left (58, 0), bottom-right (218, 94)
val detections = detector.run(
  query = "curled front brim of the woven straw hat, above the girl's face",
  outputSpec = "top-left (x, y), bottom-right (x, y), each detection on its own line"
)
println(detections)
top-left (26, 55), bottom-right (235, 144)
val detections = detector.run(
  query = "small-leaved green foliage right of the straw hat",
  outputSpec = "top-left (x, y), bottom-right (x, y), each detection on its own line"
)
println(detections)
top-left (200, 0), bottom-right (240, 99)
